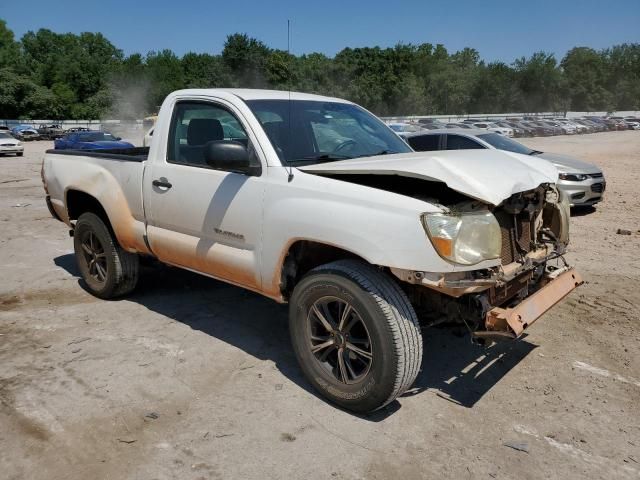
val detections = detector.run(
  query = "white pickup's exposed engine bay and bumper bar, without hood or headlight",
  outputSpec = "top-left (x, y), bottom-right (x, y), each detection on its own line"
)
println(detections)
top-left (320, 175), bottom-right (582, 340)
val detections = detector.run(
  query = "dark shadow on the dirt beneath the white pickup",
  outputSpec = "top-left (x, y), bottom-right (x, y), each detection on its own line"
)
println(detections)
top-left (54, 254), bottom-right (535, 422)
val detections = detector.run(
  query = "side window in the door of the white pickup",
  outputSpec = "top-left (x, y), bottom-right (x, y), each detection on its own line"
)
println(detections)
top-left (167, 102), bottom-right (248, 168)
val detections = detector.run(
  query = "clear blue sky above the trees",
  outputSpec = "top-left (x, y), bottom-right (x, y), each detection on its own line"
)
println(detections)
top-left (0, 0), bottom-right (640, 62)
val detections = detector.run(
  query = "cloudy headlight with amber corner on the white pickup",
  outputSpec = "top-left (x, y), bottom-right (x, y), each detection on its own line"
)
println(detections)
top-left (421, 212), bottom-right (502, 265)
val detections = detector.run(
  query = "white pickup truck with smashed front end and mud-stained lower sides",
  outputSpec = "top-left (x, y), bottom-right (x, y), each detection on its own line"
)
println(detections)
top-left (42, 89), bottom-right (581, 412)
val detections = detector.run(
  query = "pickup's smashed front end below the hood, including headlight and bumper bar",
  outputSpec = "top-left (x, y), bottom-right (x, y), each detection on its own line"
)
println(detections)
top-left (390, 184), bottom-right (582, 340)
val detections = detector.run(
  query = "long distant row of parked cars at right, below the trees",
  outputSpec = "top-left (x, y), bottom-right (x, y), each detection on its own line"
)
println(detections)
top-left (389, 116), bottom-right (640, 137)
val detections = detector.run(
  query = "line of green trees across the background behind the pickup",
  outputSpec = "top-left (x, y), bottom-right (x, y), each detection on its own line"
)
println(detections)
top-left (0, 20), bottom-right (640, 119)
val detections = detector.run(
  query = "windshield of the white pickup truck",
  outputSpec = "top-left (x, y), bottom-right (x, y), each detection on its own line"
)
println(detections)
top-left (246, 100), bottom-right (412, 165)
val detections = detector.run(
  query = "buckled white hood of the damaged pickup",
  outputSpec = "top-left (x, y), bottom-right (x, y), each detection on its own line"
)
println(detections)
top-left (299, 149), bottom-right (558, 205)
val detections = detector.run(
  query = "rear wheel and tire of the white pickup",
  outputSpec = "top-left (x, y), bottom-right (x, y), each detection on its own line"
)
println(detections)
top-left (73, 212), bottom-right (140, 299)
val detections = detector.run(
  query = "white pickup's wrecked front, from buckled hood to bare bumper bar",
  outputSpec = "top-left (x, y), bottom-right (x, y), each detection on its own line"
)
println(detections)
top-left (305, 150), bottom-right (582, 341)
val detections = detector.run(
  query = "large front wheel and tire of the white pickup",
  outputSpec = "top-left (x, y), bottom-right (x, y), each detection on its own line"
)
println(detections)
top-left (289, 260), bottom-right (422, 413)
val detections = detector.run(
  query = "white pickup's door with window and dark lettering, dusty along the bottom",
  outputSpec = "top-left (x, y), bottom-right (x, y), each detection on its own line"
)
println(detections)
top-left (143, 100), bottom-right (264, 291)
